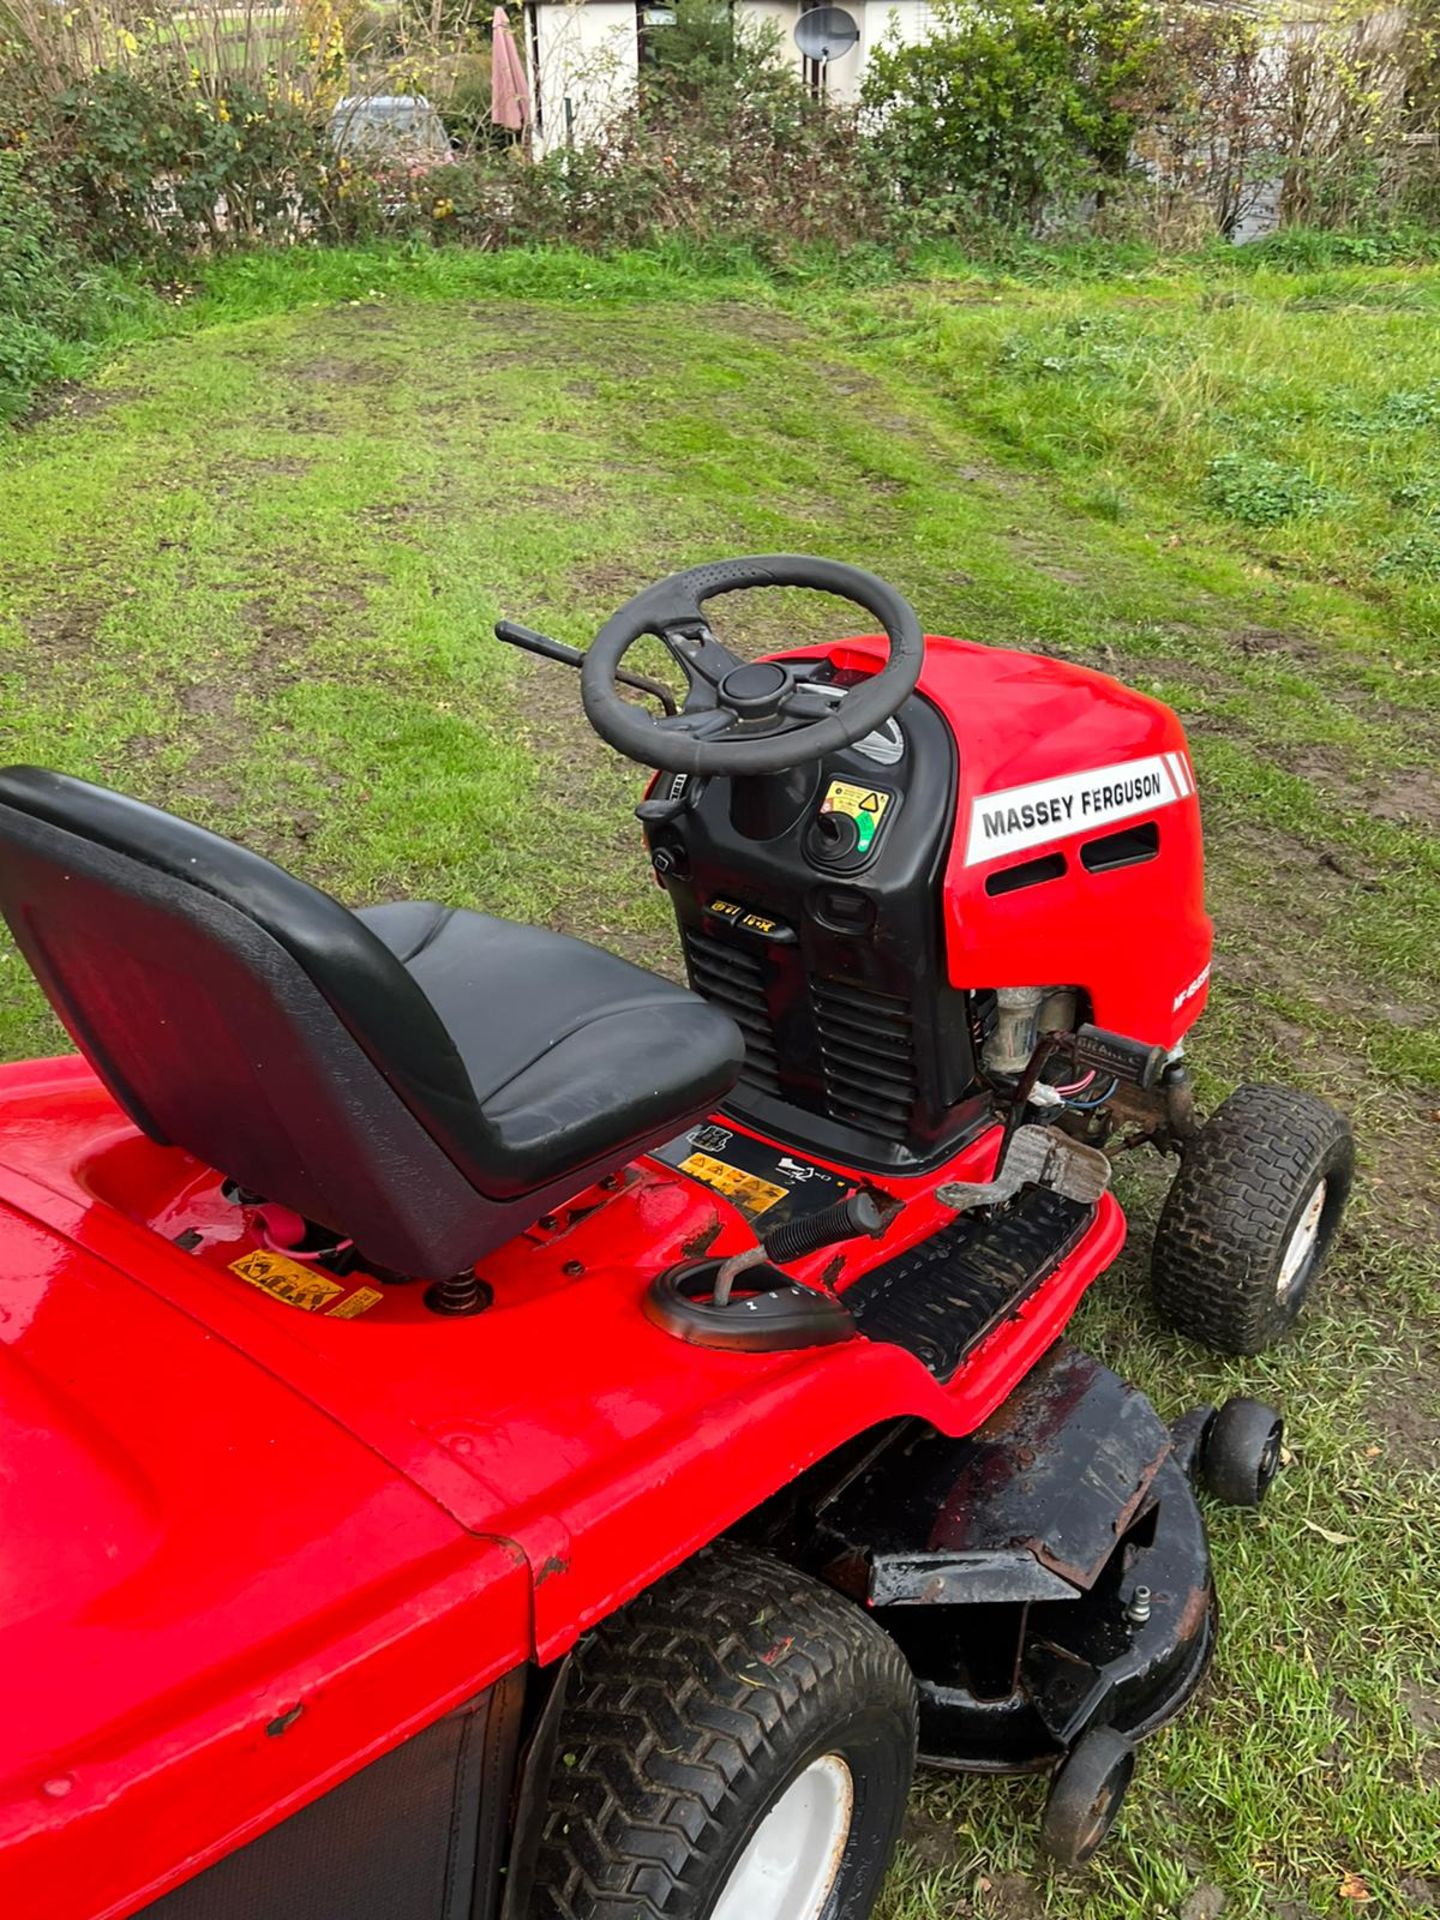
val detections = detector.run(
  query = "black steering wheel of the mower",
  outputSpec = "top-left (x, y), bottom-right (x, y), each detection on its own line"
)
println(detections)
top-left (580, 553), bottom-right (925, 776)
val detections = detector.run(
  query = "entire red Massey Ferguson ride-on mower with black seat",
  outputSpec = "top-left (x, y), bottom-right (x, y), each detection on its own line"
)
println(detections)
top-left (0, 555), bottom-right (1352, 1920)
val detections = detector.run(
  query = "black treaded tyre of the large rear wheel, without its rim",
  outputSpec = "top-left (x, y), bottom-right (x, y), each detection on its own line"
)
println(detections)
top-left (528, 1544), bottom-right (916, 1920)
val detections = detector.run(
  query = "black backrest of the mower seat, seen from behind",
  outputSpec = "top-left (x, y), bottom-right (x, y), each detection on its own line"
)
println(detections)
top-left (0, 766), bottom-right (488, 1277)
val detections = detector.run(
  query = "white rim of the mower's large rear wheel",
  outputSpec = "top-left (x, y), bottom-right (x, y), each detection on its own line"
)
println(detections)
top-left (712, 1753), bottom-right (854, 1920)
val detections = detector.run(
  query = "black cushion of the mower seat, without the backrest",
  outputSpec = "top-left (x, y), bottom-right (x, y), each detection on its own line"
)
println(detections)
top-left (359, 900), bottom-right (745, 1194)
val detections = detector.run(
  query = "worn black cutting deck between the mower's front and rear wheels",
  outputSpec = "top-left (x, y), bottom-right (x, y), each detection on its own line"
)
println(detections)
top-left (760, 1340), bottom-right (1215, 1772)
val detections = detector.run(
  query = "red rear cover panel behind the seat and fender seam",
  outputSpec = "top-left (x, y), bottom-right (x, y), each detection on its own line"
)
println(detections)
top-left (0, 1182), bottom-right (530, 1920)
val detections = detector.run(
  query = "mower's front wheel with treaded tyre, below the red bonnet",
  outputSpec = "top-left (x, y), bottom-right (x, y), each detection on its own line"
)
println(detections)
top-left (1150, 1087), bottom-right (1356, 1354)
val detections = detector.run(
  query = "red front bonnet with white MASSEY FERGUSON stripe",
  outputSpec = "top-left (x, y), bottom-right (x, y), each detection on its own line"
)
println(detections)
top-left (817, 639), bottom-right (1213, 1048)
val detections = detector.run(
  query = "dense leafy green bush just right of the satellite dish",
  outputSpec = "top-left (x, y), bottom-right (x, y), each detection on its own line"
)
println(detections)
top-left (862, 0), bottom-right (1156, 227)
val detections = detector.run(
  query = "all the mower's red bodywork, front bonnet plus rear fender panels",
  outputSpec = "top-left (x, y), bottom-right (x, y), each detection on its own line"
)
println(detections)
top-left (0, 639), bottom-right (1210, 1920)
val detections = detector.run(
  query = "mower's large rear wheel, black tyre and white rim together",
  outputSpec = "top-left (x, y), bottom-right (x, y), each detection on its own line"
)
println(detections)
top-left (530, 1546), bottom-right (916, 1920)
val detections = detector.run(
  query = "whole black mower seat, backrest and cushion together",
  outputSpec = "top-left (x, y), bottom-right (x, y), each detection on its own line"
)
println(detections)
top-left (0, 766), bottom-right (743, 1277)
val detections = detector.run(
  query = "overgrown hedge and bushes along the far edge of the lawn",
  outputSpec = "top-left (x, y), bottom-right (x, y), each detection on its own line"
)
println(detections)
top-left (0, 0), bottom-right (1440, 318)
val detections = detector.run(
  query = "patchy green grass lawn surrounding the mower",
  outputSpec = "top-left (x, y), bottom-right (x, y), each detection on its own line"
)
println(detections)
top-left (0, 255), bottom-right (1440, 1920)
